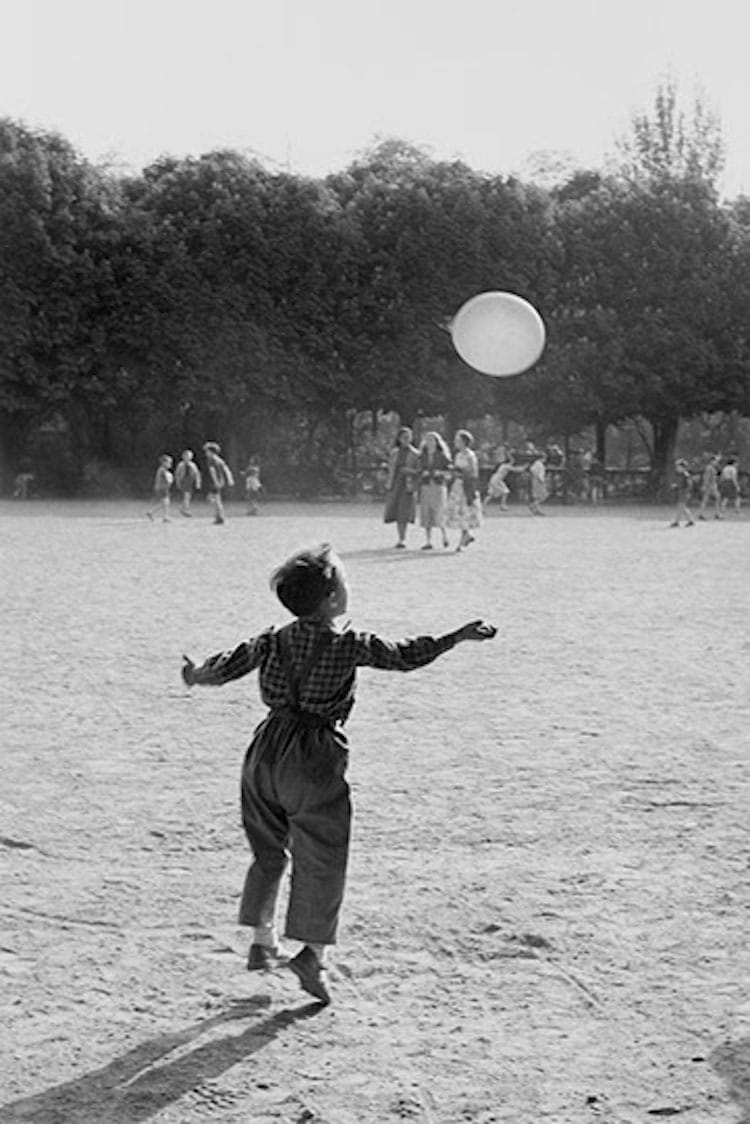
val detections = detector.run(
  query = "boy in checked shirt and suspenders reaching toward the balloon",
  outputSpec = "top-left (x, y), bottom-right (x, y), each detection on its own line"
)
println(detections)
top-left (182, 543), bottom-right (496, 1004)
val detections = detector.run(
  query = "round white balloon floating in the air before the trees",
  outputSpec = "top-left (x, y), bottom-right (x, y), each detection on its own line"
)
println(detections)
top-left (451, 292), bottom-right (546, 378)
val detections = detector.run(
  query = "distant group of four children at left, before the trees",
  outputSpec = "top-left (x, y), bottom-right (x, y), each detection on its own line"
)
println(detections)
top-left (146, 441), bottom-right (263, 524)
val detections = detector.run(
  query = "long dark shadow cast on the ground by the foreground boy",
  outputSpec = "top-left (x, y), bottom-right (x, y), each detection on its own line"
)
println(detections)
top-left (0, 996), bottom-right (324, 1124)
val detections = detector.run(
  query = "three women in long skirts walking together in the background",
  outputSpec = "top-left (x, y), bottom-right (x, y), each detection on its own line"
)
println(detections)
top-left (383, 426), bottom-right (482, 553)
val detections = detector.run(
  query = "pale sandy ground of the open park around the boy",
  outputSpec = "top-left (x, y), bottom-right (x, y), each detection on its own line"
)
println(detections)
top-left (0, 502), bottom-right (750, 1124)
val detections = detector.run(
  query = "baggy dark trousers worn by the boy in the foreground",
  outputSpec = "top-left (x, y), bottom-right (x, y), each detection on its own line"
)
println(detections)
top-left (240, 709), bottom-right (351, 944)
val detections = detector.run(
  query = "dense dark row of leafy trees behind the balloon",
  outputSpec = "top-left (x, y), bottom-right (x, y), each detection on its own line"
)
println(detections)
top-left (0, 89), bottom-right (750, 490)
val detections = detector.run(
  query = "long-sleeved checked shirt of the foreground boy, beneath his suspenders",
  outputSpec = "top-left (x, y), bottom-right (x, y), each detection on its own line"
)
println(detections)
top-left (195, 620), bottom-right (455, 722)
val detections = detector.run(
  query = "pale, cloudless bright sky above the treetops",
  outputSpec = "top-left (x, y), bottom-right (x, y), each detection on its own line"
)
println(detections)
top-left (5, 0), bottom-right (750, 196)
